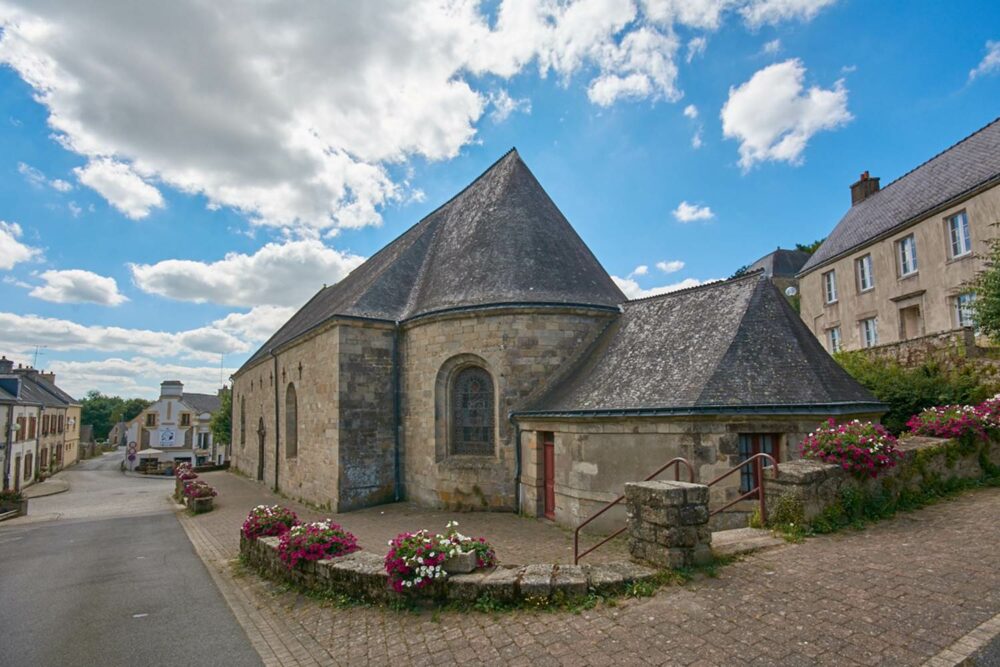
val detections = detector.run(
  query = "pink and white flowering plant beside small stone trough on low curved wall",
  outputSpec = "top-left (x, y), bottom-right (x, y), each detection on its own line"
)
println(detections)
top-left (385, 521), bottom-right (496, 592)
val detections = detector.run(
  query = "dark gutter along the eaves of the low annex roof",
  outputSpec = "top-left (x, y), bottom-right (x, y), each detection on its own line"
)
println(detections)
top-left (511, 401), bottom-right (889, 419)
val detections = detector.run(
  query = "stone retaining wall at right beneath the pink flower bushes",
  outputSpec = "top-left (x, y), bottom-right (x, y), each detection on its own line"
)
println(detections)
top-left (765, 437), bottom-right (1000, 523)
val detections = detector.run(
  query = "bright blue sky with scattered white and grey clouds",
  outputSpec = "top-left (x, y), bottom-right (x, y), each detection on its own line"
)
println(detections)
top-left (0, 0), bottom-right (1000, 398)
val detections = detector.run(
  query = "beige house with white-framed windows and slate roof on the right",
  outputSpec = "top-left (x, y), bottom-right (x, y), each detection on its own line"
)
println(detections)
top-left (799, 119), bottom-right (1000, 351)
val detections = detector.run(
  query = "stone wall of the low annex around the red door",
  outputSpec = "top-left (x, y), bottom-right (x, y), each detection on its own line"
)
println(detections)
top-left (521, 415), bottom-right (844, 533)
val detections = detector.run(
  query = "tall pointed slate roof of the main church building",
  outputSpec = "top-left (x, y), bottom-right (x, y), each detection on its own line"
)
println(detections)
top-left (243, 150), bottom-right (625, 368)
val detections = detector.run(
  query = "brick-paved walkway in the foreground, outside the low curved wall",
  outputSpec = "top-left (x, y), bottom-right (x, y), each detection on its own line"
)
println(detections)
top-left (182, 475), bottom-right (1000, 665)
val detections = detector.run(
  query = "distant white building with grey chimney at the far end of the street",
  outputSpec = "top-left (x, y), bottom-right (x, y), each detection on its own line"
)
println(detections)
top-left (125, 380), bottom-right (226, 467)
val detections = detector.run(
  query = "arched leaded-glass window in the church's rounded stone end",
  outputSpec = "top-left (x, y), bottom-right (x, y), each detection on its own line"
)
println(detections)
top-left (450, 366), bottom-right (494, 456)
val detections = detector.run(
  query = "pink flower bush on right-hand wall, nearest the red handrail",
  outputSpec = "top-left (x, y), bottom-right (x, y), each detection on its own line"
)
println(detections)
top-left (802, 419), bottom-right (903, 477)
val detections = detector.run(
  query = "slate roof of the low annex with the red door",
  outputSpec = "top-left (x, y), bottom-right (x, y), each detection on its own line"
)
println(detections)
top-left (516, 272), bottom-right (884, 416)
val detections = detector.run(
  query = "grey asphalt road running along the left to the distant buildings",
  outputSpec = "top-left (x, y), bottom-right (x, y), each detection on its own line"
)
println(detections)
top-left (0, 454), bottom-right (261, 667)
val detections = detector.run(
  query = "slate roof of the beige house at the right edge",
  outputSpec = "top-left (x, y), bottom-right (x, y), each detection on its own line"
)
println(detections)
top-left (802, 118), bottom-right (1000, 273)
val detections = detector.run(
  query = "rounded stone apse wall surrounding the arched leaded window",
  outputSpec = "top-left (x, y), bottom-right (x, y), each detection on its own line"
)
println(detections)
top-left (401, 308), bottom-right (612, 510)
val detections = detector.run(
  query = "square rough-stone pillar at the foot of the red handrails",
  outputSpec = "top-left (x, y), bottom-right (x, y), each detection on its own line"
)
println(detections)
top-left (625, 482), bottom-right (712, 568)
